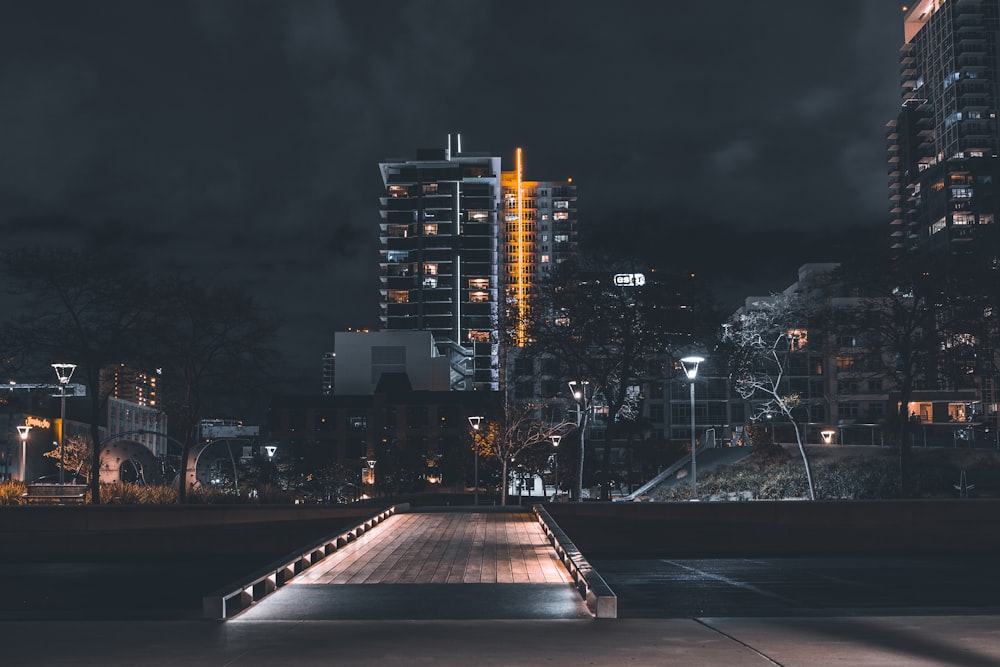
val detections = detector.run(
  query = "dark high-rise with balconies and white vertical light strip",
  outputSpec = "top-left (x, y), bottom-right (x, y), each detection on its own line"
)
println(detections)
top-left (379, 135), bottom-right (501, 390)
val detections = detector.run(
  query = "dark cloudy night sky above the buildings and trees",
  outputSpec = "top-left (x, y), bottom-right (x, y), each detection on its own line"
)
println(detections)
top-left (0, 0), bottom-right (902, 391)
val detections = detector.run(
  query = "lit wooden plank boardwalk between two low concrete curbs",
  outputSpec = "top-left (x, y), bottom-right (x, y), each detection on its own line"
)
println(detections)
top-left (289, 511), bottom-right (572, 585)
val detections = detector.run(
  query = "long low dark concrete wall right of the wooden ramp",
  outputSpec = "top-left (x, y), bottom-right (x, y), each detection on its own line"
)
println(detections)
top-left (546, 499), bottom-right (1000, 559)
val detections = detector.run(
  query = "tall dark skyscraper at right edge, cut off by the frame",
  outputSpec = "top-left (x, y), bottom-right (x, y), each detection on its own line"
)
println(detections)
top-left (887, 0), bottom-right (1000, 256)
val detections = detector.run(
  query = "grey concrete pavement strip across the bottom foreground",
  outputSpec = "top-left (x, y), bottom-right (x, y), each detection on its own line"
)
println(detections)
top-left (0, 616), bottom-right (1000, 667)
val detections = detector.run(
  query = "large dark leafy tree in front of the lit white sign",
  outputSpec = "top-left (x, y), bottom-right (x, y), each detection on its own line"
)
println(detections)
top-left (526, 259), bottom-right (718, 500)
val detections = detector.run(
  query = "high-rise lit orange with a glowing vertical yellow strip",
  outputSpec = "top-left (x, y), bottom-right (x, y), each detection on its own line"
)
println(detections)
top-left (502, 148), bottom-right (577, 347)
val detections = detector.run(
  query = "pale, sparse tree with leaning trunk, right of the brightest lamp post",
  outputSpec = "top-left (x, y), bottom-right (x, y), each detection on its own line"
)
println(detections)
top-left (722, 294), bottom-right (816, 500)
